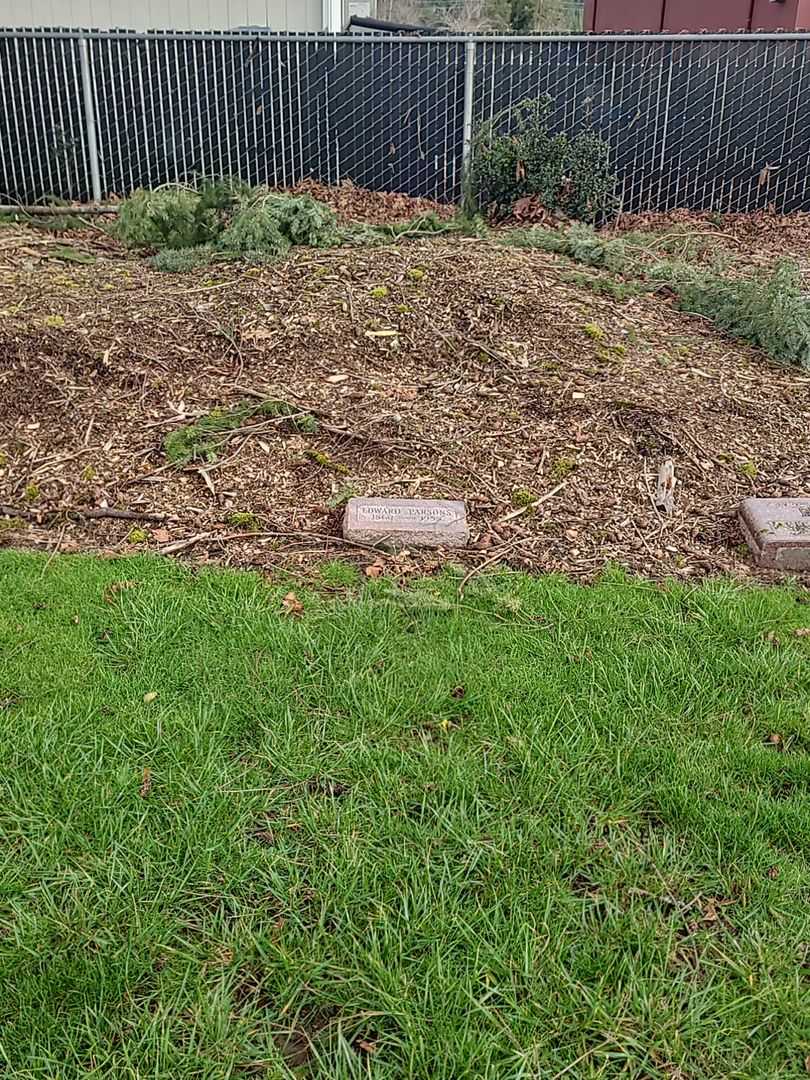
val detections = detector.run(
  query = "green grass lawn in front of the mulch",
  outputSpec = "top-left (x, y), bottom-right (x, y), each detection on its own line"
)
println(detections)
top-left (0, 552), bottom-right (810, 1080)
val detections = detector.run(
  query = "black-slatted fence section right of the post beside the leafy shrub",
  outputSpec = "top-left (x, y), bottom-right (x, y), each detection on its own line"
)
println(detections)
top-left (474, 37), bottom-right (810, 211)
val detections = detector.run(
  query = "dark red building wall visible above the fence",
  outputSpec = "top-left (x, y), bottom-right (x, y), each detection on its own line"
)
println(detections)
top-left (584, 0), bottom-right (810, 33)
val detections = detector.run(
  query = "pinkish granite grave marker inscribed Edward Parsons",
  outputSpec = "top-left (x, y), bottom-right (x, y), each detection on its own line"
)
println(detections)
top-left (343, 499), bottom-right (470, 548)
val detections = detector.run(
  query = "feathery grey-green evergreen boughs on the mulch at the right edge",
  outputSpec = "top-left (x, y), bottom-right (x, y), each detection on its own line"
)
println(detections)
top-left (674, 260), bottom-right (810, 368)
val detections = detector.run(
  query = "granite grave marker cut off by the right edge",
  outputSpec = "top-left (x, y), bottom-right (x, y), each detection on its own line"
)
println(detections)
top-left (740, 499), bottom-right (810, 570)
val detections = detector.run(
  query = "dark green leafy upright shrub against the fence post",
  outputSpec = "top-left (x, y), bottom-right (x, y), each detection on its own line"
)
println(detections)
top-left (468, 96), bottom-right (618, 221)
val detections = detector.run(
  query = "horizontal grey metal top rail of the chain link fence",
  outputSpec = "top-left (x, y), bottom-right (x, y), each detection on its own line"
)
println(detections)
top-left (0, 27), bottom-right (810, 45)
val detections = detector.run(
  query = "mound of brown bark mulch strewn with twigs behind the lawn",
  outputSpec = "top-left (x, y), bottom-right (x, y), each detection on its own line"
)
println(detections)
top-left (0, 189), bottom-right (810, 579)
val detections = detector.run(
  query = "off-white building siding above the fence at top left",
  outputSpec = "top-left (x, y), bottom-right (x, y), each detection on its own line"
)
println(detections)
top-left (0, 0), bottom-right (336, 31)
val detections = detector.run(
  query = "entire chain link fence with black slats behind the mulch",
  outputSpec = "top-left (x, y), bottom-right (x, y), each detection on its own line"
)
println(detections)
top-left (0, 30), bottom-right (810, 212)
